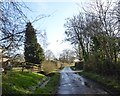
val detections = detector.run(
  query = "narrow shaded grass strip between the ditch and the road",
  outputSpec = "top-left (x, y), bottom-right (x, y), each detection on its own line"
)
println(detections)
top-left (35, 73), bottom-right (60, 94)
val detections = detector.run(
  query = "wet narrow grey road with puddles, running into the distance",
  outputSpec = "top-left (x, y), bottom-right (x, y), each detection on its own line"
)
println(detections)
top-left (57, 67), bottom-right (108, 96)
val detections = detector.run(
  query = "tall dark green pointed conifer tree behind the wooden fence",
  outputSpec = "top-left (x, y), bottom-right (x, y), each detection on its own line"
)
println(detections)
top-left (24, 22), bottom-right (44, 64)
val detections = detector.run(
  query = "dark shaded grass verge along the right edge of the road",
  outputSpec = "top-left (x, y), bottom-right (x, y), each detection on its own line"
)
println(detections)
top-left (71, 66), bottom-right (120, 94)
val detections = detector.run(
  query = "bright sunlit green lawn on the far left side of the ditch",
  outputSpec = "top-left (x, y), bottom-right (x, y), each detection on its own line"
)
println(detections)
top-left (2, 71), bottom-right (44, 95)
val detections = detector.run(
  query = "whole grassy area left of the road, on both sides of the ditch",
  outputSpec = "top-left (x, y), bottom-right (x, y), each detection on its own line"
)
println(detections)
top-left (2, 71), bottom-right (60, 96)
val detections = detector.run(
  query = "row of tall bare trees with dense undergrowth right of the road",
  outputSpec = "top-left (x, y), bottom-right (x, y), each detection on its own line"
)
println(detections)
top-left (65, 0), bottom-right (120, 79)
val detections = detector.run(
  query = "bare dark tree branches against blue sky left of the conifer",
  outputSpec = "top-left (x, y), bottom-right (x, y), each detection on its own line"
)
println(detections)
top-left (0, 0), bottom-right (28, 55)
